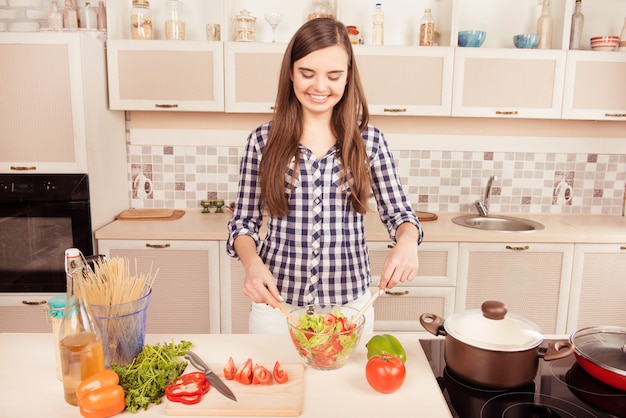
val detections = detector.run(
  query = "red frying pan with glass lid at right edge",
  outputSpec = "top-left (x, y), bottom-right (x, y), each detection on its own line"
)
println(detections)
top-left (570, 325), bottom-right (626, 391)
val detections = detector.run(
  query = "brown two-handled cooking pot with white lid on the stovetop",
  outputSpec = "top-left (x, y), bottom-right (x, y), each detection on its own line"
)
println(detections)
top-left (420, 301), bottom-right (574, 388)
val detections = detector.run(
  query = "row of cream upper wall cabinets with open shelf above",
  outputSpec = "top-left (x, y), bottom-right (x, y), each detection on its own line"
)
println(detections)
top-left (107, 0), bottom-right (626, 120)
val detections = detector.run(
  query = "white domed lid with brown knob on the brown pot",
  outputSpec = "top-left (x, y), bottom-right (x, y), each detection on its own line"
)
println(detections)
top-left (444, 301), bottom-right (543, 351)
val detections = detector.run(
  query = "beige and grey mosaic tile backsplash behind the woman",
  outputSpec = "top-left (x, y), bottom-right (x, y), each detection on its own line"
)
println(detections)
top-left (128, 145), bottom-right (626, 215)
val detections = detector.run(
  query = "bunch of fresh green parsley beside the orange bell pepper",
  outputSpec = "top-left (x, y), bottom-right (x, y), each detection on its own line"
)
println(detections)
top-left (111, 341), bottom-right (192, 414)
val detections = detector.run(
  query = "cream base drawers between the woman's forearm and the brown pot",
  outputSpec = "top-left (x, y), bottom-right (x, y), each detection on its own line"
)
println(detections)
top-left (368, 242), bottom-right (458, 332)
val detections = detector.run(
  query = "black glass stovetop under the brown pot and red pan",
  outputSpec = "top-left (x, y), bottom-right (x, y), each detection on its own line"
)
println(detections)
top-left (420, 338), bottom-right (626, 418)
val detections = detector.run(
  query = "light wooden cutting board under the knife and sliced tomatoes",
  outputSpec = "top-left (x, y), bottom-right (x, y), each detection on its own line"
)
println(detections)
top-left (165, 363), bottom-right (304, 417)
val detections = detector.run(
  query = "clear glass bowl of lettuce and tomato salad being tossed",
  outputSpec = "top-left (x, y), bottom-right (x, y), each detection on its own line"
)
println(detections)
top-left (289, 308), bottom-right (361, 369)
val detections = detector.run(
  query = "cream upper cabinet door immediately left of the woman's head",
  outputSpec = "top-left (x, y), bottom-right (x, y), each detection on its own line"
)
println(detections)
top-left (224, 42), bottom-right (287, 113)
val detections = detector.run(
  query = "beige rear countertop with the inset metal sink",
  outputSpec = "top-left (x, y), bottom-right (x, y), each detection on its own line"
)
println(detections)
top-left (95, 209), bottom-right (626, 244)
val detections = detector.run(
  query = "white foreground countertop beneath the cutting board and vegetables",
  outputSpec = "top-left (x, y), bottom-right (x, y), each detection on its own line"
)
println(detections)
top-left (0, 333), bottom-right (452, 418)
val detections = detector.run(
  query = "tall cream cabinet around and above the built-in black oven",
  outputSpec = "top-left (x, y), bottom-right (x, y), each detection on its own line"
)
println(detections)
top-left (0, 32), bottom-right (128, 230)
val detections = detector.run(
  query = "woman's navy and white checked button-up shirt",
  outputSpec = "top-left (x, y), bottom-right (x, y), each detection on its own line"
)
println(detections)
top-left (226, 122), bottom-right (423, 306)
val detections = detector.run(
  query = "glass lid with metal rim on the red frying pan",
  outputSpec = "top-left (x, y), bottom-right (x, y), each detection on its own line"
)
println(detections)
top-left (570, 326), bottom-right (626, 376)
